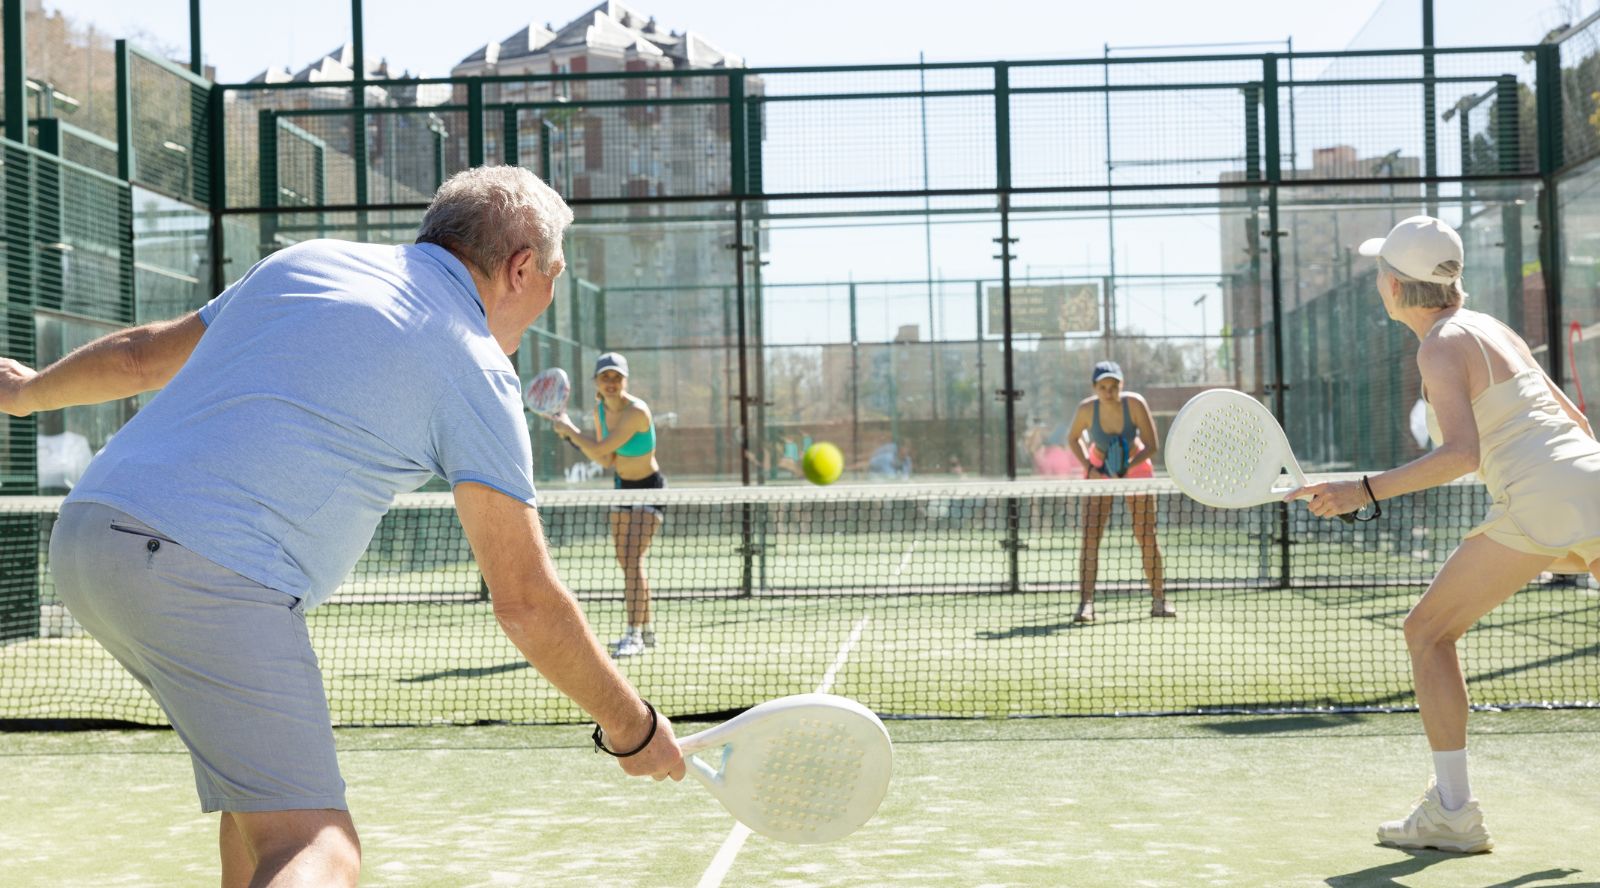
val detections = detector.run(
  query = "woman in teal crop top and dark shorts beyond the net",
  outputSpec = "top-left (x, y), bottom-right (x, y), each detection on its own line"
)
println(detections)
top-left (555, 352), bottom-right (667, 658)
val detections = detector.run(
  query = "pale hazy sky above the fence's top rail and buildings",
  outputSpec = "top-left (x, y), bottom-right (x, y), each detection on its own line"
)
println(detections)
top-left (45, 0), bottom-right (1594, 82)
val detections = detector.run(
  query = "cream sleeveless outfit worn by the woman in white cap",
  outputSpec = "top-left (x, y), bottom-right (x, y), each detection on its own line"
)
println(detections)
top-left (1427, 310), bottom-right (1600, 571)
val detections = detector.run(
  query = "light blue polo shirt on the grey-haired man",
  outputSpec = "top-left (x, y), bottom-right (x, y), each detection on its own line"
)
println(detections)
top-left (67, 240), bottom-right (534, 608)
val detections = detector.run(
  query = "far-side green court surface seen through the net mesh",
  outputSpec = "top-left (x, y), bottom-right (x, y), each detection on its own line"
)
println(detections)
top-left (12, 587), bottom-right (1600, 725)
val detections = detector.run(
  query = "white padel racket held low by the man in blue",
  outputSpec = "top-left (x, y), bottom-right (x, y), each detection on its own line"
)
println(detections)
top-left (678, 694), bottom-right (894, 845)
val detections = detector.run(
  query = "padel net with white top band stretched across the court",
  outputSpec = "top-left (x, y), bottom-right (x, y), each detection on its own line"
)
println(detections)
top-left (0, 478), bottom-right (1600, 725)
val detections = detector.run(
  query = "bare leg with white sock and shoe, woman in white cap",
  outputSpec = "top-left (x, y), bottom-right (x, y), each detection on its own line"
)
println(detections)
top-left (1378, 534), bottom-right (1550, 851)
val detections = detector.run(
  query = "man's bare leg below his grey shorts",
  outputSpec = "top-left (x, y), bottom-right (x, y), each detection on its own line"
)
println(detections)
top-left (222, 810), bottom-right (362, 886)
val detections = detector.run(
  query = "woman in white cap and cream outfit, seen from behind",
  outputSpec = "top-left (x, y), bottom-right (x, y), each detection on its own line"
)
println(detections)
top-left (1290, 216), bottom-right (1600, 853)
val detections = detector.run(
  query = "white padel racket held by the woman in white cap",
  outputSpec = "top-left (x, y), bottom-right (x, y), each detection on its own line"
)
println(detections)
top-left (1162, 389), bottom-right (1355, 523)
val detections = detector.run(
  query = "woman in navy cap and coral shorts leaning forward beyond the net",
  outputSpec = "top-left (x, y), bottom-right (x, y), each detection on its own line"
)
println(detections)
top-left (1067, 360), bottom-right (1178, 622)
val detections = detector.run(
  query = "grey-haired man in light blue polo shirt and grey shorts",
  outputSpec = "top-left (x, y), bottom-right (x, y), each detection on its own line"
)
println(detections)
top-left (0, 166), bottom-right (683, 885)
